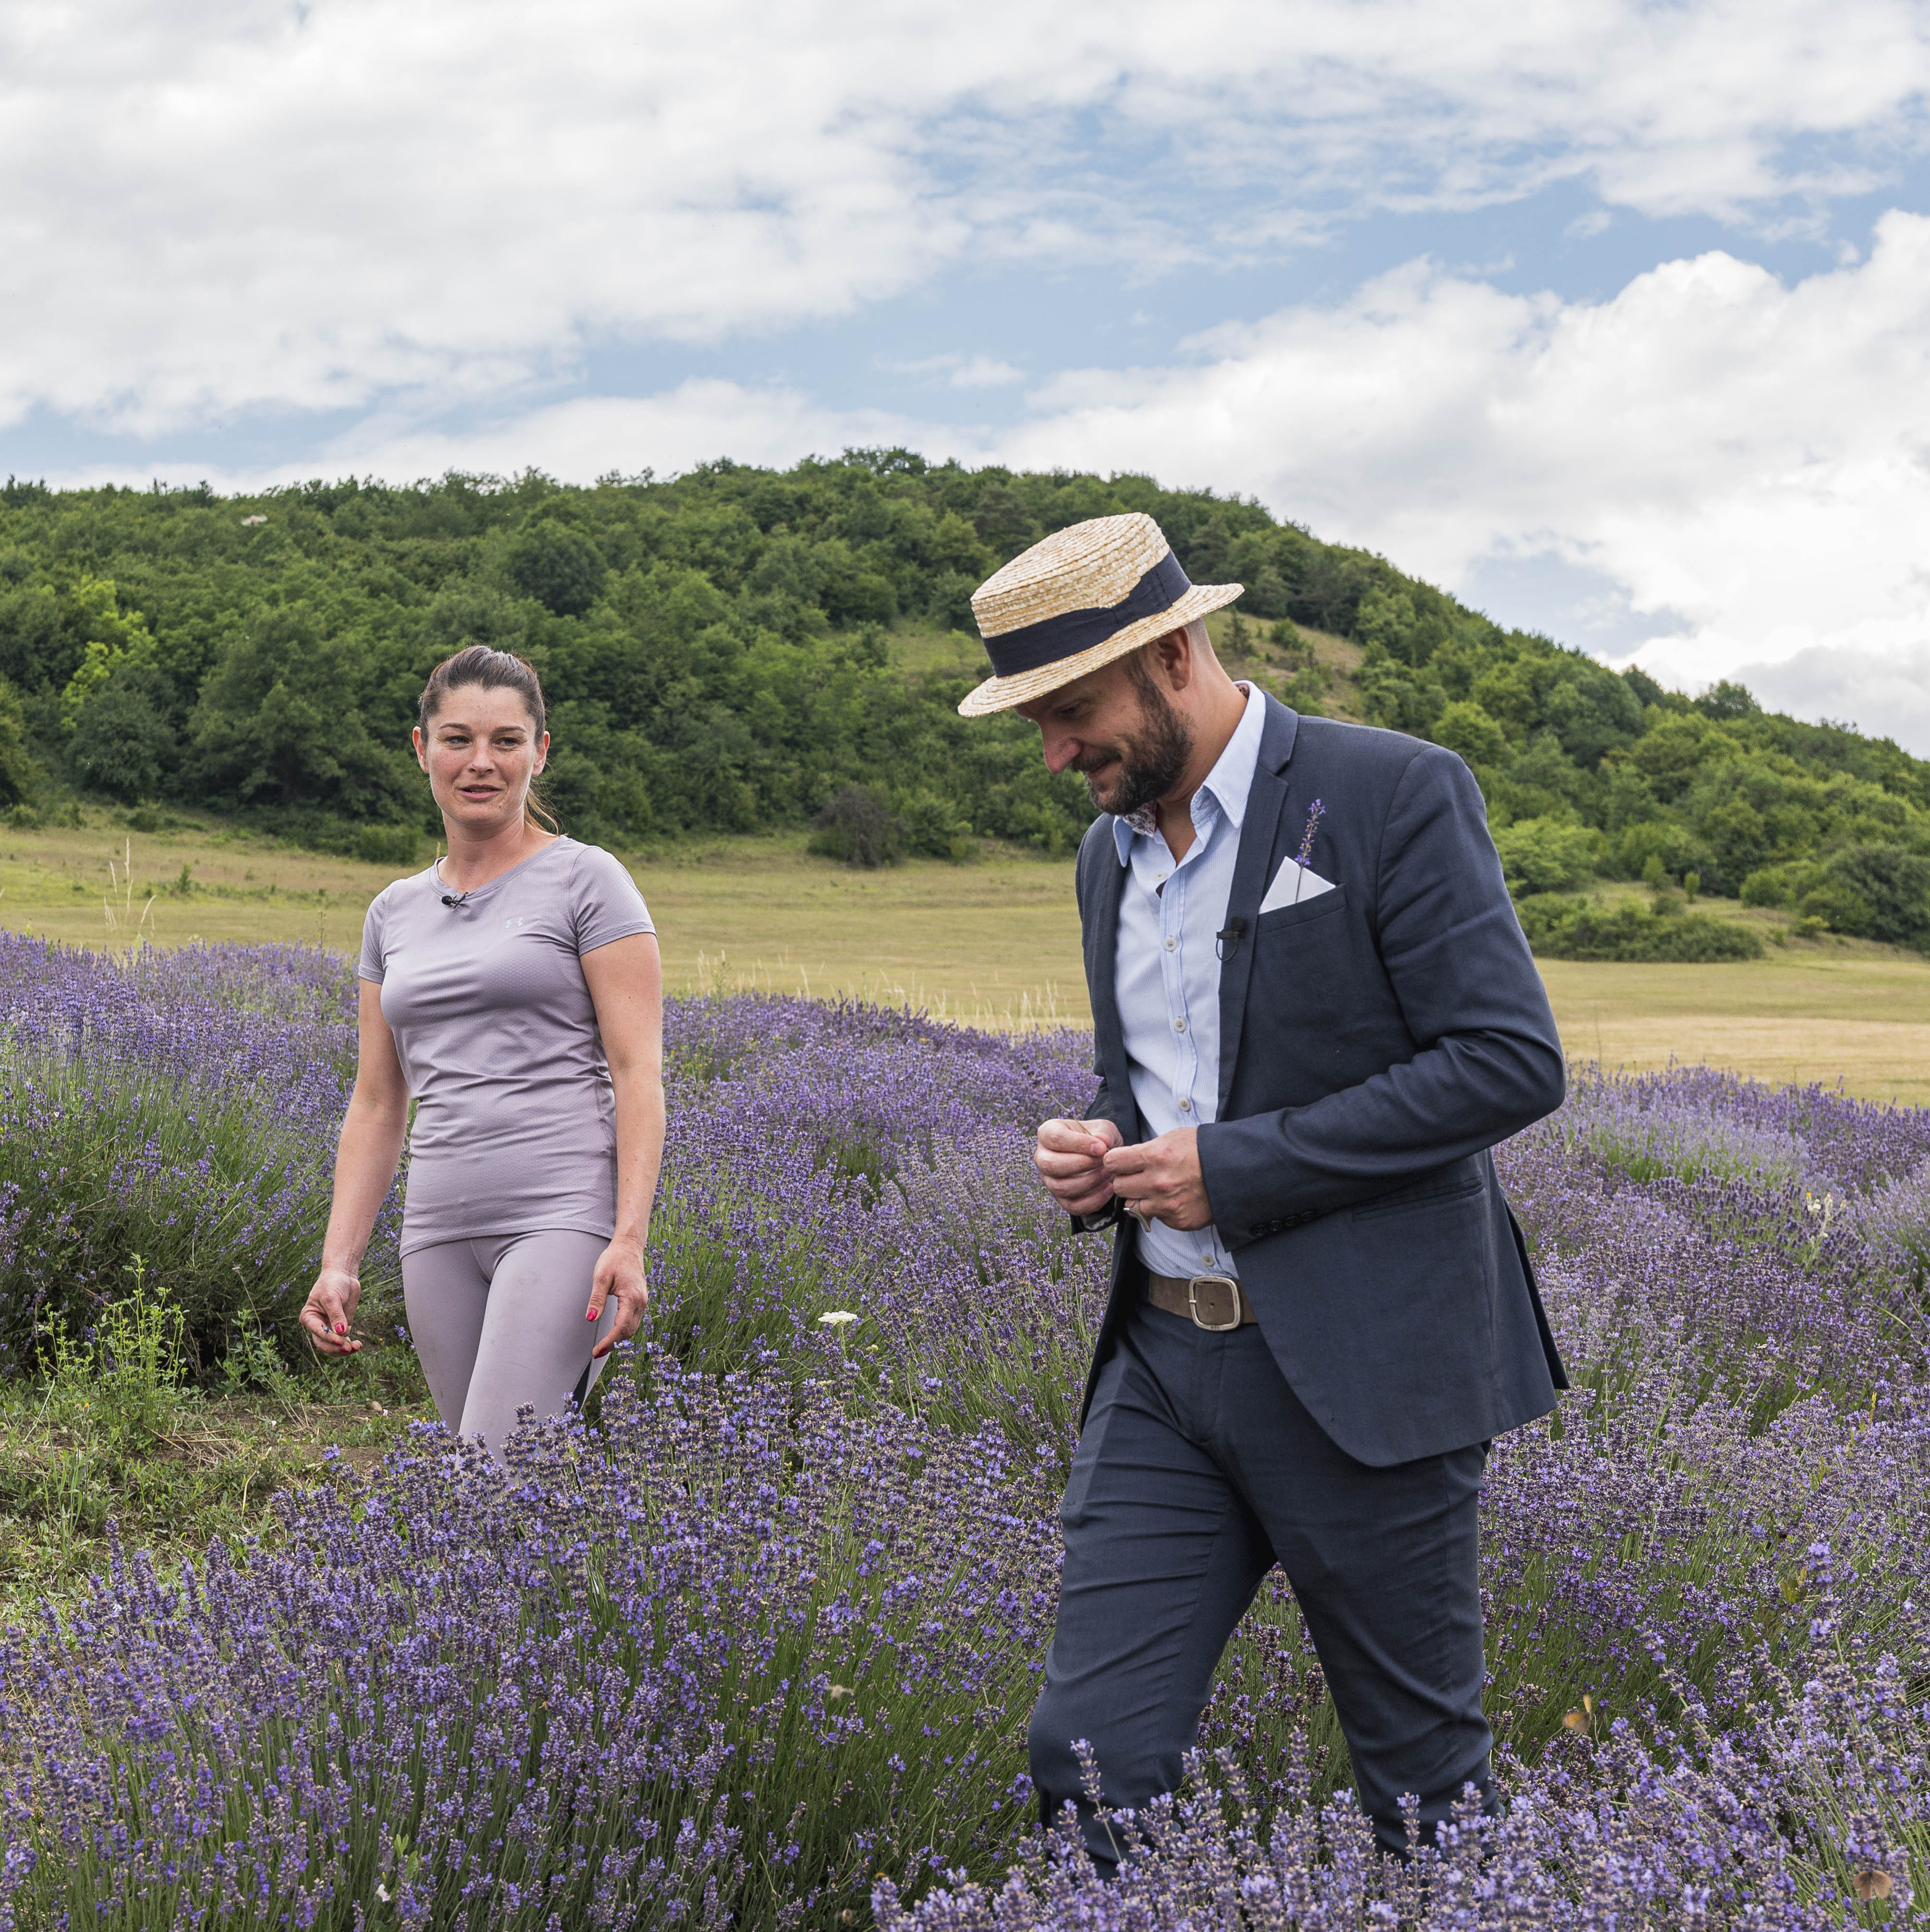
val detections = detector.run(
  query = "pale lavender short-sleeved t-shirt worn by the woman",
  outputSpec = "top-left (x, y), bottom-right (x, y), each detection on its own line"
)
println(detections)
top-left (359, 838), bottom-right (655, 1254)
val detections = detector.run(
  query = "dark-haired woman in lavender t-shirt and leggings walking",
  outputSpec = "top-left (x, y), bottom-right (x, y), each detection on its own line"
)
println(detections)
top-left (302, 643), bottom-right (663, 1459)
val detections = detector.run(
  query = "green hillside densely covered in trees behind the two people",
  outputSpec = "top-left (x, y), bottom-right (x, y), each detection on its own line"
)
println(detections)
top-left (0, 450), bottom-right (1930, 958)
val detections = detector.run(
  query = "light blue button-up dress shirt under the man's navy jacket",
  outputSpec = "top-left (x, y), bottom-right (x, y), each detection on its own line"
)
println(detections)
top-left (1113, 684), bottom-right (1267, 1275)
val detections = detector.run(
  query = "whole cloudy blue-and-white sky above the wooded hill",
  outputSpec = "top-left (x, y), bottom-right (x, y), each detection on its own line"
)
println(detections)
top-left (0, 0), bottom-right (1930, 738)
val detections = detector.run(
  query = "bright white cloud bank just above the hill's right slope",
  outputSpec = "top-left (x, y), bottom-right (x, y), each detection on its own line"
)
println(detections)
top-left (981, 215), bottom-right (1930, 749)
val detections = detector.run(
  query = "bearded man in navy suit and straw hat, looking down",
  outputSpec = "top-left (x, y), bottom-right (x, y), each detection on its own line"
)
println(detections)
top-left (960, 514), bottom-right (1567, 1870)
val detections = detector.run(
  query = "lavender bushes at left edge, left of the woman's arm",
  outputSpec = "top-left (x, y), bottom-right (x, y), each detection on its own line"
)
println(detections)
top-left (0, 933), bottom-right (394, 1374)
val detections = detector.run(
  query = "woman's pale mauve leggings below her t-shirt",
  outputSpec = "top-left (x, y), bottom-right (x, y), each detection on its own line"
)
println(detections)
top-left (402, 1229), bottom-right (616, 1461)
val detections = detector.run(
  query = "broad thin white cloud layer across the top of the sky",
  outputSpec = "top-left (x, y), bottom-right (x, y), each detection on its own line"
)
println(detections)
top-left (0, 0), bottom-right (1930, 435)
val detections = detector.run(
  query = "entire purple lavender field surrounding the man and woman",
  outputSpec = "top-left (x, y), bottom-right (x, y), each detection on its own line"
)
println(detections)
top-left (0, 939), bottom-right (1930, 1932)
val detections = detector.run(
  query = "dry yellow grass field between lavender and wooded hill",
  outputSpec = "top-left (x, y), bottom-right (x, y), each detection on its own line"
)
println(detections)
top-left (0, 813), bottom-right (1930, 1105)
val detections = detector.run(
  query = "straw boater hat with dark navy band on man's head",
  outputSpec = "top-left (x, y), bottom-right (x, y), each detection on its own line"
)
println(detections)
top-left (958, 510), bottom-right (1246, 719)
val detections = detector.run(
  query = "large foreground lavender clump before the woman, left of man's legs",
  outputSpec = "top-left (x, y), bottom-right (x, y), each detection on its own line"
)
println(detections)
top-left (0, 1356), bottom-right (1057, 1932)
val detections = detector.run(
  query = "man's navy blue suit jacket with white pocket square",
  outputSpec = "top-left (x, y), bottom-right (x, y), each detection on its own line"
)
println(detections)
top-left (1078, 700), bottom-right (1567, 1464)
